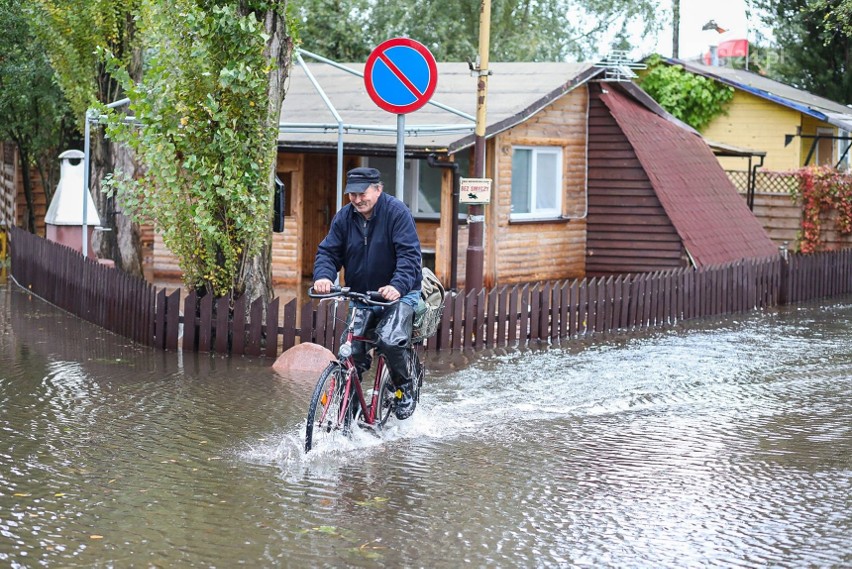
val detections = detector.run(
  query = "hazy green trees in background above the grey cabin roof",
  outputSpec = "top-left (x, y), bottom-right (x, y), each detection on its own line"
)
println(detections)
top-left (294, 0), bottom-right (662, 61)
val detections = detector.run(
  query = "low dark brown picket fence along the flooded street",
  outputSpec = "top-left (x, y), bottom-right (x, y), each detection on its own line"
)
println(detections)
top-left (6, 228), bottom-right (852, 357)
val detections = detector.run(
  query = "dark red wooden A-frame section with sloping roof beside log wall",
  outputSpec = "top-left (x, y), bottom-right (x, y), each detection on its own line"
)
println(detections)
top-left (586, 82), bottom-right (777, 275)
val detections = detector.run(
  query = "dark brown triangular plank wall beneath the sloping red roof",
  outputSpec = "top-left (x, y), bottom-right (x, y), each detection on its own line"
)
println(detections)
top-left (586, 83), bottom-right (688, 276)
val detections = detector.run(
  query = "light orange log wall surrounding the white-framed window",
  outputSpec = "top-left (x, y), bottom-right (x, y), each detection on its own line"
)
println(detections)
top-left (484, 87), bottom-right (588, 287)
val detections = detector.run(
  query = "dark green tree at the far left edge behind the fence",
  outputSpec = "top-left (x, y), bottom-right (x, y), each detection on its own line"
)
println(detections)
top-left (0, 0), bottom-right (73, 232)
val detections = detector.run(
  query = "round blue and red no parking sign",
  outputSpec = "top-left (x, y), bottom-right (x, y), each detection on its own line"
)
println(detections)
top-left (364, 38), bottom-right (438, 115)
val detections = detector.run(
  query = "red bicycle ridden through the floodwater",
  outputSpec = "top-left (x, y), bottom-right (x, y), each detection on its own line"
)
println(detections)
top-left (305, 286), bottom-right (424, 452)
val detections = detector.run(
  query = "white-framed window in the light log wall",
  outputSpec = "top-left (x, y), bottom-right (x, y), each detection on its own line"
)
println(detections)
top-left (511, 146), bottom-right (562, 219)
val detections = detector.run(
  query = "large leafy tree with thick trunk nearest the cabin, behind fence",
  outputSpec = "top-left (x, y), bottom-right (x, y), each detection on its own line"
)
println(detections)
top-left (102, 0), bottom-right (292, 299)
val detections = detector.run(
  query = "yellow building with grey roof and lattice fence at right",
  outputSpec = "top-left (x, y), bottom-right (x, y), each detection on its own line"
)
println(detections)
top-left (644, 58), bottom-right (852, 250)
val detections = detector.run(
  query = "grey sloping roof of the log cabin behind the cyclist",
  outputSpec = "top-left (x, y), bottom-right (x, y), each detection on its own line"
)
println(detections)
top-left (278, 57), bottom-right (602, 152)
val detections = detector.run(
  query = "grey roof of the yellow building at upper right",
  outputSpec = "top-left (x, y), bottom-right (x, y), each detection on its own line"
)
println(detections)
top-left (670, 60), bottom-right (852, 130)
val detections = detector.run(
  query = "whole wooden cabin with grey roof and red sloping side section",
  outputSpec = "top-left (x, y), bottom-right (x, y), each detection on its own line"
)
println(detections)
top-left (274, 58), bottom-right (777, 287)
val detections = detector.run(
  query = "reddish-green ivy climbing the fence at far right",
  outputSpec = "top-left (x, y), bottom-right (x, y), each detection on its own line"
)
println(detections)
top-left (790, 166), bottom-right (852, 253)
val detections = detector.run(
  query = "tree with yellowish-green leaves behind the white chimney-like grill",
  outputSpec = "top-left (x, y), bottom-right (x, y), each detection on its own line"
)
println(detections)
top-left (26, 0), bottom-right (142, 276)
